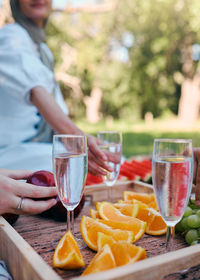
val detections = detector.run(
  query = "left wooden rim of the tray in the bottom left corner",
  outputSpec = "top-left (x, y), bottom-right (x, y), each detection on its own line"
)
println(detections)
top-left (0, 216), bottom-right (61, 280)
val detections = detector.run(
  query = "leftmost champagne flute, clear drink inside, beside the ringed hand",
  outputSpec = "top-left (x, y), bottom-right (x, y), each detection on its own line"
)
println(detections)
top-left (53, 134), bottom-right (88, 243)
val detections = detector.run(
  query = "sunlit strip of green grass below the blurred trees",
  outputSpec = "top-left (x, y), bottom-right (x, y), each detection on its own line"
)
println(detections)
top-left (77, 118), bottom-right (200, 158)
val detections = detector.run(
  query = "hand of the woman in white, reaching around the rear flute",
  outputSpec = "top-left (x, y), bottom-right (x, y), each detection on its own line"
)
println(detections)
top-left (87, 135), bottom-right (113, 176)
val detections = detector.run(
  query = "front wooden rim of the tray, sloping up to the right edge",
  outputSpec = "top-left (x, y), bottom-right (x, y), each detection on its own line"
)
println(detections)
top-left (73, 244), bottom-right (200, 280)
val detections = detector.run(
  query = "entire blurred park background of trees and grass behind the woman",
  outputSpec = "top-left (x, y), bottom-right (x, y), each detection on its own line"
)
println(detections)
top-left (0, 0), bottom-right (200, 157)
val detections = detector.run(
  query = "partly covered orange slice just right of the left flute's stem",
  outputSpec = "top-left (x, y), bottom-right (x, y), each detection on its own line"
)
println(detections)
top-left (80, 216), bottom-right (135, 251)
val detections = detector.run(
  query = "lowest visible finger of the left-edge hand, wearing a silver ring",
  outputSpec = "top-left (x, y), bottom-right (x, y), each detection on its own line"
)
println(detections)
top-left (16, 198), bottom-right (57, 214)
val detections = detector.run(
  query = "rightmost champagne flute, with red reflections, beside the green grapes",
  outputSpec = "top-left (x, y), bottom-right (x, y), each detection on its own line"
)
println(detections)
top-left (152, 139), bottom-right (193, 251)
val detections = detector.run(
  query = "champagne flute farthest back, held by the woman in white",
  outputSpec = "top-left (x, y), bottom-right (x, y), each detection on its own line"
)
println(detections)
top-left (97, 131), bottom-right (122, 201)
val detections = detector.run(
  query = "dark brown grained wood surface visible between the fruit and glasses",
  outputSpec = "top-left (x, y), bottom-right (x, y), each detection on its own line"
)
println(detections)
top-left (14, 197), bottom-right (200, 280)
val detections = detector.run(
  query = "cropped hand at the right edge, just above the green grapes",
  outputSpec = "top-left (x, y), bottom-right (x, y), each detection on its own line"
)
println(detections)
top-left (193, 148), bottom-right (200, 206)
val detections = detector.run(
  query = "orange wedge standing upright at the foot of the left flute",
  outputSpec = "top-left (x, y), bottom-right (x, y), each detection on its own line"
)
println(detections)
top-left (53, 231), bottom-right (85, 269)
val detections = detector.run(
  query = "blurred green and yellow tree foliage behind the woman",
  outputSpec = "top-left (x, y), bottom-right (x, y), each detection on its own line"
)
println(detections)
top-left (47, 0), bottom-right (200, 119)
